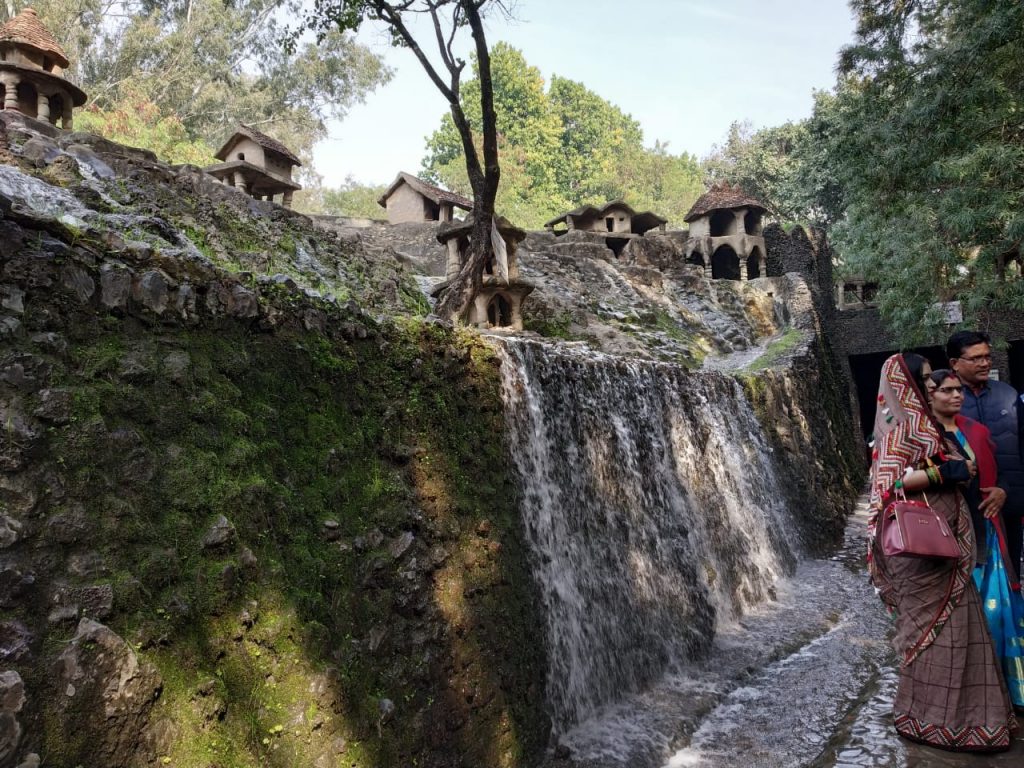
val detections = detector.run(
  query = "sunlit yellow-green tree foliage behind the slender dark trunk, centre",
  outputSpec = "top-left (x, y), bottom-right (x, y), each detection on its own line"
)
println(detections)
top-left (423, 42), bottom-right (703, 227)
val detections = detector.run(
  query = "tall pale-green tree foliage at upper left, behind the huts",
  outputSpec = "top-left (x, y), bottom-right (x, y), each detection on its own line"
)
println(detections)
top-left (3, 0), bottom-right (389, 174)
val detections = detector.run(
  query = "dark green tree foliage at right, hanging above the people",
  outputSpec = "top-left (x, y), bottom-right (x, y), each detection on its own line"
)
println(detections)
top-left (812, 0), bottom-right (1024, 343)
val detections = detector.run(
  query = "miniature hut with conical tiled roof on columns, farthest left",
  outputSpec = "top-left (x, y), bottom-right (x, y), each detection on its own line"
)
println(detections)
top-left (0, 8), bottom-right (86, 130)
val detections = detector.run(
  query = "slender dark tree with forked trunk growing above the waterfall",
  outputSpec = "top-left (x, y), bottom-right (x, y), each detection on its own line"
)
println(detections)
top-left (303, 0), bottom-right (510, 322)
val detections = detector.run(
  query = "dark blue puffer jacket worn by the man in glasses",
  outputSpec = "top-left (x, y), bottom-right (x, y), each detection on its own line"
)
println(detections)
top-left (961, 381), bottom-right (1024, 505)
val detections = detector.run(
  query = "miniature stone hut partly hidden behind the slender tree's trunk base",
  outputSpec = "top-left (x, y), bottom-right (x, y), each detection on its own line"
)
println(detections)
top-left (431, 216), bottom-right (534, 331)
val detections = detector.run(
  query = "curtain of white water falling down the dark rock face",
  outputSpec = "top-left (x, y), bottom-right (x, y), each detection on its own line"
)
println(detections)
top-left (501, 339), bottom-right (796, 732)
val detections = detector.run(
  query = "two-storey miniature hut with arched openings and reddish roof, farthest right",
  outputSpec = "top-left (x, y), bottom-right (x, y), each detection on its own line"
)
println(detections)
top-left (684, 183), bottom-right (767, 280)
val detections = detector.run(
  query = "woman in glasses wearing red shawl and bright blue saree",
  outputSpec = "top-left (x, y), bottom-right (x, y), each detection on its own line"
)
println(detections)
top-left (928, 369), bottom-right (1024, 710)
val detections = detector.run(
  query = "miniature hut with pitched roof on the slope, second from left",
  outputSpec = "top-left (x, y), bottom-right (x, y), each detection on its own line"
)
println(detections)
top-left (206, 124), bottom-right (302, 208)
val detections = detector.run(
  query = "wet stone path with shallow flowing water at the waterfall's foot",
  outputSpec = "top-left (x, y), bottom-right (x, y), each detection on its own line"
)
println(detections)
top-left (546, 500), bottom-right (1024, 768)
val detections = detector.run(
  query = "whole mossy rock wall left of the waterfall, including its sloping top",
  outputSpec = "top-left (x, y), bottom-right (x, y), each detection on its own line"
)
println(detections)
top-left (0, 114), bottom-right (549, 768)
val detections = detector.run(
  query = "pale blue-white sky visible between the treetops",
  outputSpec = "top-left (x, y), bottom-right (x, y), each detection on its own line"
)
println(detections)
top-left (313, 0), bottom-right (854, 186)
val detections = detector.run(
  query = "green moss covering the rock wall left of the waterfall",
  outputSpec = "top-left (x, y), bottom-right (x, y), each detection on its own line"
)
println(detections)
top-left (34, 318), bottom-right (547, 768)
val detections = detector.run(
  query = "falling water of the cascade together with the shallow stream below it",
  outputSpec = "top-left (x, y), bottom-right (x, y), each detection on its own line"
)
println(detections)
top-left (502, 339), bottom-right (1024, 768)
